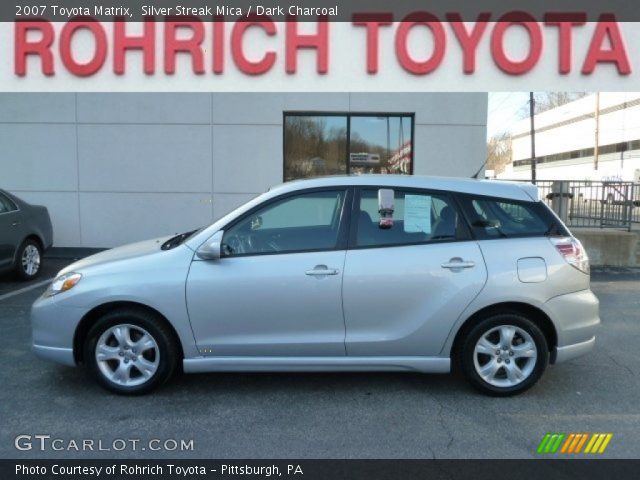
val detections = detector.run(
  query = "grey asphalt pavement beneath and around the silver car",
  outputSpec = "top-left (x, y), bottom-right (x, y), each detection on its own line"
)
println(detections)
top-left (0, 261), bottom-right (640, 459)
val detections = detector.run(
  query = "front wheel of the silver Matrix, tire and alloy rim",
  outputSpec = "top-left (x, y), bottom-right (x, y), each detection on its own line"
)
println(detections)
top-left (84, 309), bottom-right (180, 395)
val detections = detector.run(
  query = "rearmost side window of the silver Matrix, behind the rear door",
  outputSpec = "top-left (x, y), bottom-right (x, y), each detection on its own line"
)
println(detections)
top-left (460, 195), bottom-right (566, 239)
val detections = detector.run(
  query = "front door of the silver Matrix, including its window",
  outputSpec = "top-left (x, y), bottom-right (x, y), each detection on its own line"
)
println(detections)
top-left (187, 189), bottom-right (350, 356)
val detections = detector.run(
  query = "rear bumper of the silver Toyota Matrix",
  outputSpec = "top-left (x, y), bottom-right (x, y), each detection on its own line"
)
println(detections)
top-left (544, 290), bottom-right (600, 363)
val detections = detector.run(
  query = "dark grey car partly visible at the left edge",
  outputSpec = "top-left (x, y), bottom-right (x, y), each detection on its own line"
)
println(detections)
top-left (0, 190), bottom-right (53, 280)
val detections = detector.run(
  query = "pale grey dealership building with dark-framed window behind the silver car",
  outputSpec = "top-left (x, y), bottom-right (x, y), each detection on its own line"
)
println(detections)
top-left (0, 93), bottom-right (487, 248)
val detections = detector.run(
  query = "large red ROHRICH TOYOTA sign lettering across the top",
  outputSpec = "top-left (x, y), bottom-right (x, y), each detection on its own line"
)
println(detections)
top-left (13, 12), bottom-right (632, 77)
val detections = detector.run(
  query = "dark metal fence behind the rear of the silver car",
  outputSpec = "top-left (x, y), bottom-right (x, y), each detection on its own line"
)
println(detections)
top-left (504, 180), bottom-right (640, 230)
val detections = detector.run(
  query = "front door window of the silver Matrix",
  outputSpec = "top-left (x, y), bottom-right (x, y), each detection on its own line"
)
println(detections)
top-left (222, 190), bottom-right (346, 257)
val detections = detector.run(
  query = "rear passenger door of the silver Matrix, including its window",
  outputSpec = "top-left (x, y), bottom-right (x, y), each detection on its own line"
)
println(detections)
top-left (343, 189), bottom-right (487, 356)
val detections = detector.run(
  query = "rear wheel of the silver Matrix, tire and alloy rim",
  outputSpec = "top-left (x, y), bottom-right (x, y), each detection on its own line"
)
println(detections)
top-left (460, 313), bottom-right (549, 397)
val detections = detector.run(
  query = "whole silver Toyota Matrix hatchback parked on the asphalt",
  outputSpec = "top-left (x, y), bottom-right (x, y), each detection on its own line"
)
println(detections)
top-left (31, 175), bottom-right (600, 395)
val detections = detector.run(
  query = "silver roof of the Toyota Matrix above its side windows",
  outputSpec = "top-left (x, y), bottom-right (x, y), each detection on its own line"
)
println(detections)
top-left (270, 175), bottom-right (539, 202)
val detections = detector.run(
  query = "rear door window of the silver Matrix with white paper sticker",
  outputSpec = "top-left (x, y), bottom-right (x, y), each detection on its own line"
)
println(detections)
top-left (352, 189), bottom-right (466, 247)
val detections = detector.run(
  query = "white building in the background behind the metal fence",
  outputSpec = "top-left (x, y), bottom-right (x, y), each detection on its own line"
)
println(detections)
top-left (498, 92), bottom-right (640, 182)
